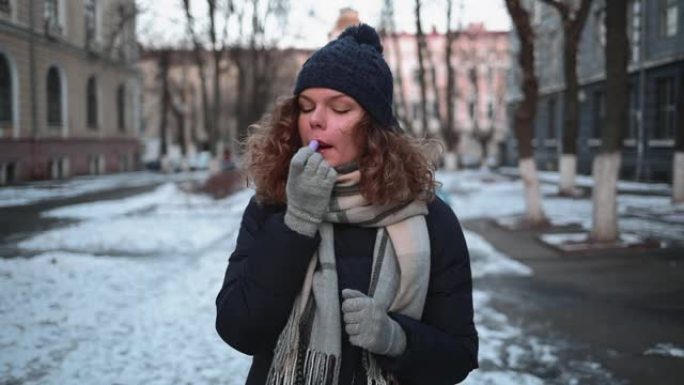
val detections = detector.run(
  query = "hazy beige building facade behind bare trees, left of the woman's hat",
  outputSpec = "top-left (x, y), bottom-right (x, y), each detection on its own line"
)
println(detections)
top-left (138, 47), bottom-right (312, 168)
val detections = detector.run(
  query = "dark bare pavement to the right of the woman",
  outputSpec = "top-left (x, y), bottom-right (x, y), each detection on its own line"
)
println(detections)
top-left (463, 219), bottom-right (684, 385)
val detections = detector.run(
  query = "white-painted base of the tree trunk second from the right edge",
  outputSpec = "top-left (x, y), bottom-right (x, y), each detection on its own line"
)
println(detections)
top-left (591, 152), bottom-right (621, 242)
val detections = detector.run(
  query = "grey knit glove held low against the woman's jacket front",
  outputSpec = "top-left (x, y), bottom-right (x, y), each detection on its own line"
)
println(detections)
top-left (342, 289), bottom-right (406, 357)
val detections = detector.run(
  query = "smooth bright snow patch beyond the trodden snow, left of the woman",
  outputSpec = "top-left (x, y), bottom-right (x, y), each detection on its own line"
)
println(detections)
top-left (18, 185), bottom-right (252, 255)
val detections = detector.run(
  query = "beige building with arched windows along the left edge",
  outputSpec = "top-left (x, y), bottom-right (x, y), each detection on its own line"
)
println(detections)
top-left (0, 0), bottom-right (140, 184)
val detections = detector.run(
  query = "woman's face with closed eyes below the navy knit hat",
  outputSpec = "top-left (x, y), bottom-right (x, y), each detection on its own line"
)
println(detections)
top-left (297, 88), bottom-right (365, 167)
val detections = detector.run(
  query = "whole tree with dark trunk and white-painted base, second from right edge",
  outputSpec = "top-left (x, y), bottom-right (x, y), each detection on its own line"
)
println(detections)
top-left (591, 1), bottom-right (629, 242)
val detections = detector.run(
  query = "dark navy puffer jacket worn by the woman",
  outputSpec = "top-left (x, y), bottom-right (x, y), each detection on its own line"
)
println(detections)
top-left (216, 198), bottom-right (478, 385)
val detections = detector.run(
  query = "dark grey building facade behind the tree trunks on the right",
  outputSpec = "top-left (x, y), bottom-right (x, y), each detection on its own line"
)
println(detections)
top-left (506, 0), bottom-right (684, 181)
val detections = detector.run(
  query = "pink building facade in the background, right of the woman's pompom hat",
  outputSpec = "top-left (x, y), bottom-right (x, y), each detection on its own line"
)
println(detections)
top-left (383, 23), bottom-right (510, 167)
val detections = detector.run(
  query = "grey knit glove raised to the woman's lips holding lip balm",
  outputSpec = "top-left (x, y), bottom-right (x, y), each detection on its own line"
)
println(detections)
top-left (285, 146), bottom-right (337, 237)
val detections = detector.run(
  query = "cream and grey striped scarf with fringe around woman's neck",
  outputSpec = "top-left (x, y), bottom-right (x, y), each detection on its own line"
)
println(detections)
top-left (266, 170), bottom-right (430, 385)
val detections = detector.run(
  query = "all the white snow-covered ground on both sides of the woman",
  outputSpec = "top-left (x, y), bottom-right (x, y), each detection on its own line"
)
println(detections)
top-left (0, 172), bottom-right (681, 385)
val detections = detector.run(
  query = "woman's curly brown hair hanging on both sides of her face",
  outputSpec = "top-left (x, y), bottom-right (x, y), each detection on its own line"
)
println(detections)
top-left (244, 96), bottom-right (442, 204)
